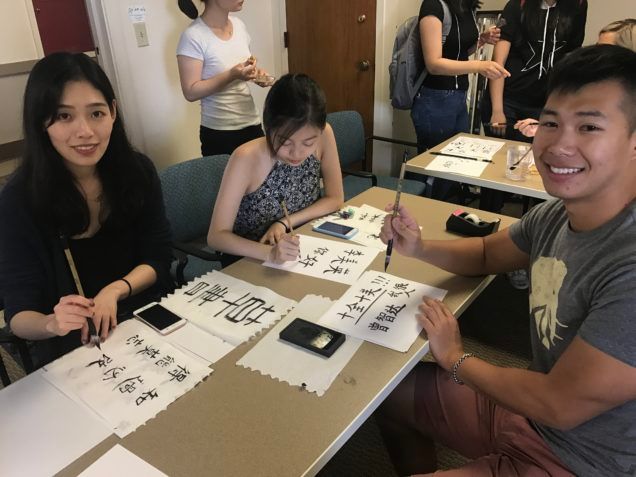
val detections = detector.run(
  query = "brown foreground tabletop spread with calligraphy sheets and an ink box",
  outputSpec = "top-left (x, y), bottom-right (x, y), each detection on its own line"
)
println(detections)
top-left (56, 188), bottom-right (516, 476)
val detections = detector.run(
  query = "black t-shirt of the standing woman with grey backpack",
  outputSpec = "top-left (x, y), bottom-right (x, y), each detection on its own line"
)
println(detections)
top-left (419, 0), bottom-right (479, 90)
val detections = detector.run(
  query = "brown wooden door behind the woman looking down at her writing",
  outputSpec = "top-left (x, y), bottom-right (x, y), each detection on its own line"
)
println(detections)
top-left (285, 0), bottom-right (376, 165)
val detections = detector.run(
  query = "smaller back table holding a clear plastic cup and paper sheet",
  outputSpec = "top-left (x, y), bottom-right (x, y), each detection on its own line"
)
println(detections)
top-left (406, 133), bottom-right (552, 199)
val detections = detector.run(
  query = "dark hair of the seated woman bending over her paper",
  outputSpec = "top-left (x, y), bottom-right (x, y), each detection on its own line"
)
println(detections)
top-left (263, 73), bottom-right (327, 154)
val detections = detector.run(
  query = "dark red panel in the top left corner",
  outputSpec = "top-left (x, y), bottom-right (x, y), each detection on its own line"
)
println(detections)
top-left (32, 0), bottom-right (95, 55)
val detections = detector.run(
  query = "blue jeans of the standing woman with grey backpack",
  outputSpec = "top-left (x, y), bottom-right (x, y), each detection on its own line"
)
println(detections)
top-left (411, 86), bottom-right (469, 200)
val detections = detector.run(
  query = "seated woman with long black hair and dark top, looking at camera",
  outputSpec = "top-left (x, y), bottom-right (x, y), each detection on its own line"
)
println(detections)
top-left (0, 53), bottom-right (171, 364)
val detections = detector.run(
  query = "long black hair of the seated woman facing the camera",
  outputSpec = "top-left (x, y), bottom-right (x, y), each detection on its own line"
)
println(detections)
top-left (17, 53), bottom-right (152, 236)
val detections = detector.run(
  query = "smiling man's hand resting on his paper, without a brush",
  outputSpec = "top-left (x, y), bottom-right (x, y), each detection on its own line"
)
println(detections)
top-left (415, 297), bottom-right (464, 371)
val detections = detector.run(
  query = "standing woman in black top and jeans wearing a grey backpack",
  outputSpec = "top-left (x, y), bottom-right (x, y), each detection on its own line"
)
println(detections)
top-left (411, 0), bottom-right (510, 199)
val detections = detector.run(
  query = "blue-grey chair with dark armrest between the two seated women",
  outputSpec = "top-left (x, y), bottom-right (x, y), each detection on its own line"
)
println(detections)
top-left (159, 154), bottom-right (230, 285)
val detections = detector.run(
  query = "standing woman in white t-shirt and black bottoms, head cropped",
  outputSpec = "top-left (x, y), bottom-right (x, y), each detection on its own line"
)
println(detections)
top-left (177, 0), bottom-right (273, 156)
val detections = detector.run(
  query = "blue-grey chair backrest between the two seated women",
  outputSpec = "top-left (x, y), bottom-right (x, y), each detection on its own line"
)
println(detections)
top-left (159, 154), bottom-right (230, 242)
